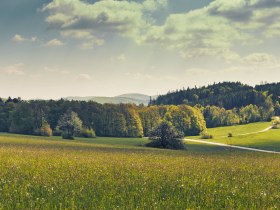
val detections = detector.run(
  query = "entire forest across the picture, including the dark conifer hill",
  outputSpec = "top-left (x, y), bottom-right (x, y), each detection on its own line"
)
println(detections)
top-left (0, 82), bottom-right (280, 137)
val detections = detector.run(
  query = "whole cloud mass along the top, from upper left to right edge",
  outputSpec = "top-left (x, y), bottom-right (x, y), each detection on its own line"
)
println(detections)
top-left (43, 0), bottom-right (280, 62)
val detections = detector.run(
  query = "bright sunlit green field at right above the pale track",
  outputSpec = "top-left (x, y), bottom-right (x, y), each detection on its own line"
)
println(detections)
top-left (190, 122), bottom-right (280, 151)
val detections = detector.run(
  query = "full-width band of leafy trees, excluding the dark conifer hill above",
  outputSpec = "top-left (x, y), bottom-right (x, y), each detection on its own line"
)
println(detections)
top-left (0, 90), bottom-right (280, 138)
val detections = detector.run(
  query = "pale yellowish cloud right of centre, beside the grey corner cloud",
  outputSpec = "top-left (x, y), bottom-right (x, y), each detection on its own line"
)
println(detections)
top-left (142, 8), bottom-right (249, 59)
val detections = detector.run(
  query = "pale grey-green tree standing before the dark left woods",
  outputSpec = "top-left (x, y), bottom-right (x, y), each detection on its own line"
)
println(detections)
top-left (57, 111), bottom-right (83, 139)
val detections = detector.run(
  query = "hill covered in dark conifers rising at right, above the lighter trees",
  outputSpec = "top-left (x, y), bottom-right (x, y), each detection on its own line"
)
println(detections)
top-left (152, 82), bottom-right (280, 109)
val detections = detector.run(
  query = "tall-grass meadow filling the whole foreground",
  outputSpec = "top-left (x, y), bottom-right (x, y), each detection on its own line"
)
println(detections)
top-left (0, 134), bottom-right (280, 209)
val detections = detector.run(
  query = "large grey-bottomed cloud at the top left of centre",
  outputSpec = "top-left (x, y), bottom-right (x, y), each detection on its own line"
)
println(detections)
top-left (43, 0), bottom-right (167, 44)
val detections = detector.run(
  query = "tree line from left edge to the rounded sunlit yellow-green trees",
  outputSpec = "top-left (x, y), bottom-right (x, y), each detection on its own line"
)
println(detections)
top-left (0, 98), bottom-right (206, 138)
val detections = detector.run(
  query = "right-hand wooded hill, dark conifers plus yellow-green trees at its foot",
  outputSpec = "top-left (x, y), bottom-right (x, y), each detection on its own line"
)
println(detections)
top-left (150, 82), bottom-right (280, 127)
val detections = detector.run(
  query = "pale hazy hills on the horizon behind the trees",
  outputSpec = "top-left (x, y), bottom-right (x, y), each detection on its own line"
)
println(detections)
top-left (65, 93), bottom-right (156, 105)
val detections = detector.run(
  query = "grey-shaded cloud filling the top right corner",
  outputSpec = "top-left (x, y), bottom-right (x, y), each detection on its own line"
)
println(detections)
top-left (208, 0), bottom-right (280, 38)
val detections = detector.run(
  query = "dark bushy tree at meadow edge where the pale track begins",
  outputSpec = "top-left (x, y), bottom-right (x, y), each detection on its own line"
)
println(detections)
top-left (146, 121), bottom-right (185, 149)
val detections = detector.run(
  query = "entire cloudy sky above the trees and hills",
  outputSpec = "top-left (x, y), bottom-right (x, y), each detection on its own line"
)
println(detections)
top-left (0, 0), bottom-right (280, 99)
